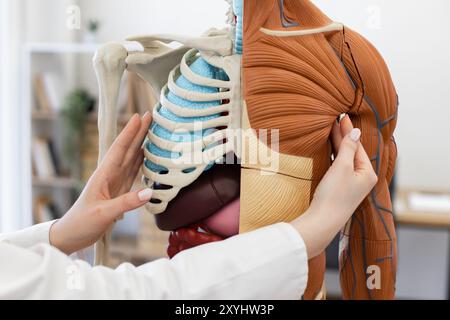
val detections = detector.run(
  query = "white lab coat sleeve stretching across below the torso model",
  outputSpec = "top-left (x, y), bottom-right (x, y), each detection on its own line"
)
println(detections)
top-left (0, 223), bottom-right (308, 299)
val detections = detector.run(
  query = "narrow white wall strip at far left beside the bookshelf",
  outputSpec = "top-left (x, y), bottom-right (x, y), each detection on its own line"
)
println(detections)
top-left (0, 0), bottom-right (24, 232)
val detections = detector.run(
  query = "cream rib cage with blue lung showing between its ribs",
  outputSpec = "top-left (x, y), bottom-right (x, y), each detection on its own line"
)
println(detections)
top-left (144, 45), bottom-right (240, 214)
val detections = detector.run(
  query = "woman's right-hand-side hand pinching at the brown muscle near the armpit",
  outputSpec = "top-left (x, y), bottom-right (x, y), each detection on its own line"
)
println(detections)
top-left (292, 116), bottom-right (378, 259)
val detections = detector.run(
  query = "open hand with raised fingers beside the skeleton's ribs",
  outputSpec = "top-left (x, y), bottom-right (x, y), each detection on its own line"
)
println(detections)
top-left (50, 113), bottom-right (152, 254)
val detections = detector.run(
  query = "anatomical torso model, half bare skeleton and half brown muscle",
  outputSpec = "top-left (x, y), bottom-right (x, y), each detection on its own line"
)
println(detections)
top-left (94, 0), bottom-right (398, 299)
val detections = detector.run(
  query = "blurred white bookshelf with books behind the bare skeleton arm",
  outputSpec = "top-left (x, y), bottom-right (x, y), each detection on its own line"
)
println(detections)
top-left (23, 43), bottom-right (168, 266)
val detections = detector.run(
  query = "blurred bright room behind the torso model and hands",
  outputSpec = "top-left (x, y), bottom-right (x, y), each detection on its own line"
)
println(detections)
top-left (0, 0), bottom-right (450, 299)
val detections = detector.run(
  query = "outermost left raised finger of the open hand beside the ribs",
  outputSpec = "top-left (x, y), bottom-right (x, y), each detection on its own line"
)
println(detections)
top-left (105, 114), bottom-right (141, 166)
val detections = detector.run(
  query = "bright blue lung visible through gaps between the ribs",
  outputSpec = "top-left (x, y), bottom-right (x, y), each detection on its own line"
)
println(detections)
top-left (145, 57), bottom-right (229, 173)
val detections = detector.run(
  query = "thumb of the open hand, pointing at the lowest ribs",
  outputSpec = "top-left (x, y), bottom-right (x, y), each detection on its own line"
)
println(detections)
top-left (105, 188), bottom-right (153, 218)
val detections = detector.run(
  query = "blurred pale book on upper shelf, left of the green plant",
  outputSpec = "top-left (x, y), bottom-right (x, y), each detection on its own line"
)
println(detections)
top-left (33, 72), bottom-right (64, 113)
